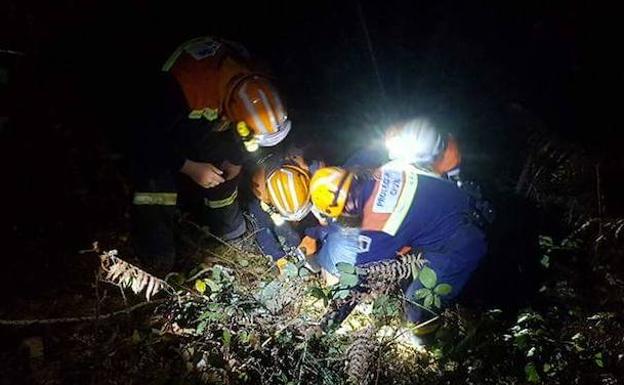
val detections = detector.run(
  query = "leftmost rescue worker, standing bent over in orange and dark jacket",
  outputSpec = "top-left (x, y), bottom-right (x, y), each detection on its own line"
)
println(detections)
top-left (132, 37), bottom-right (291, 272)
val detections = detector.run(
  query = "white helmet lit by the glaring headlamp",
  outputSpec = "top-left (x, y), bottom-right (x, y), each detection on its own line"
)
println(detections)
top-left (386, 118), bottom-right (444, 164)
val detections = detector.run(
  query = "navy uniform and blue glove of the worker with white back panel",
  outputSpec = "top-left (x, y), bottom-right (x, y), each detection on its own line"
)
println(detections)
top-left (318, 162), bottom-right (486, 321)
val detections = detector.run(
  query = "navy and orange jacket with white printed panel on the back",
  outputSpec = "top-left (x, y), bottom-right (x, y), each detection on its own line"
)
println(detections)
top-left (357, 162), bottom-right (485, 264)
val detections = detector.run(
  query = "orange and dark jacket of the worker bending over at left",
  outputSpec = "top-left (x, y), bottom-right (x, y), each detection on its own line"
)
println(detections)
top-left (132, 37), bottom-right (251, 178)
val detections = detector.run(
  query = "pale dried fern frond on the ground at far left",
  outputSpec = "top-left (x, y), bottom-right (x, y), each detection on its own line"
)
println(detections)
top-left (100, 250), bottom-right (173, 301)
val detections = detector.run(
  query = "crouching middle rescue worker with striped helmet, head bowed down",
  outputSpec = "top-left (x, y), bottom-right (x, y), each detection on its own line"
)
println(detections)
top-left (249, 150), bottom-right (323, 270)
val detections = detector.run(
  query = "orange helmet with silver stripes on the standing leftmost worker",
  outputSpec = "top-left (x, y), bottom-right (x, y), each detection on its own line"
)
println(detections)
top-left (224, 74), bottom-right (291, 147)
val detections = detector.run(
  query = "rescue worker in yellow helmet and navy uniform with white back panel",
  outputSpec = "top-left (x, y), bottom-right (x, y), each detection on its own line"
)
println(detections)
top-left (310, 161), bottom-right (486, 322)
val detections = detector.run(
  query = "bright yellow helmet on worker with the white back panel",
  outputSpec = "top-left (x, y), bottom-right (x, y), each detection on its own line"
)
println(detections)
top-left (310, 167), bottom-right (353, 218)
